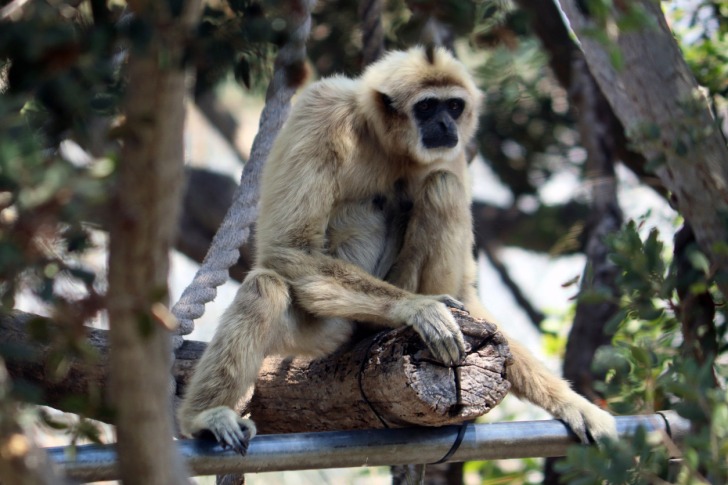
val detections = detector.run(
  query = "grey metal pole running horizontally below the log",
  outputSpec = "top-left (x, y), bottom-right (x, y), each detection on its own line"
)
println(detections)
top-left (47, 411), bottom-right (690, 481)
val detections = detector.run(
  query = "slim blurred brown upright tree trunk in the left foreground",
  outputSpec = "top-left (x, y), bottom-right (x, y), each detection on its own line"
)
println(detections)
top-left (107, 0), bottom-right (200, 485)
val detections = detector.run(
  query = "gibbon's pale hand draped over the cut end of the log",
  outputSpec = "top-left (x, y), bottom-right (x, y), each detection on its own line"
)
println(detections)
top-left (404, 295), bottom-right (465, 365)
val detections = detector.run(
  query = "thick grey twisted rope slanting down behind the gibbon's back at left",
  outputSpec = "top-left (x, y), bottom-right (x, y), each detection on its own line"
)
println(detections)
top-left (172, 0), bottom-right (316, 349)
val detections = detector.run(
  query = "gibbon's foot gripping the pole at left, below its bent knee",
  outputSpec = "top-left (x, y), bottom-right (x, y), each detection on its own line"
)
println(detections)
top-left (193, 406), bottom-right (256, 456)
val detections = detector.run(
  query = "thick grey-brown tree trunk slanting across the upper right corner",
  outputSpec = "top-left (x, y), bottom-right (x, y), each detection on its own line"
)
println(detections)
top-left (560, 0), bottom-right (728, 294)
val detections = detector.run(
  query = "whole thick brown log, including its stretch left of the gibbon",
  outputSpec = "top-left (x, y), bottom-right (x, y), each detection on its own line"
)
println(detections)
top-left (0, 310), bottom-right (511, 433)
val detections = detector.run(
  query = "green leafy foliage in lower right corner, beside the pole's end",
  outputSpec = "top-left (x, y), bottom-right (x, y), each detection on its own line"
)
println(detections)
top-left (559, 223), bottom-right (728, 484)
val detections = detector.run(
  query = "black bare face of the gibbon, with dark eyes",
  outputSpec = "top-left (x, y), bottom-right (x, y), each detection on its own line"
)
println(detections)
top-left (413, 98), bottom-right (465, 149)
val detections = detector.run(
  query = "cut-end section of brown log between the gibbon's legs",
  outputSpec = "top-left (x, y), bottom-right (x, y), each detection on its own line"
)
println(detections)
top-left (250, 310), bottom-right (510, 433)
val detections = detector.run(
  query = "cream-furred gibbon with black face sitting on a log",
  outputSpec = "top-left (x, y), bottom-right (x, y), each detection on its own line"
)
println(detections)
top-left (178, 47), bottom-right (616, 454)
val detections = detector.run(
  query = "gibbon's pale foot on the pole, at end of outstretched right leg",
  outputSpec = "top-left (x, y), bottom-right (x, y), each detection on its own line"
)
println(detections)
top-left (555, 396), bottom-right (618, 444)
